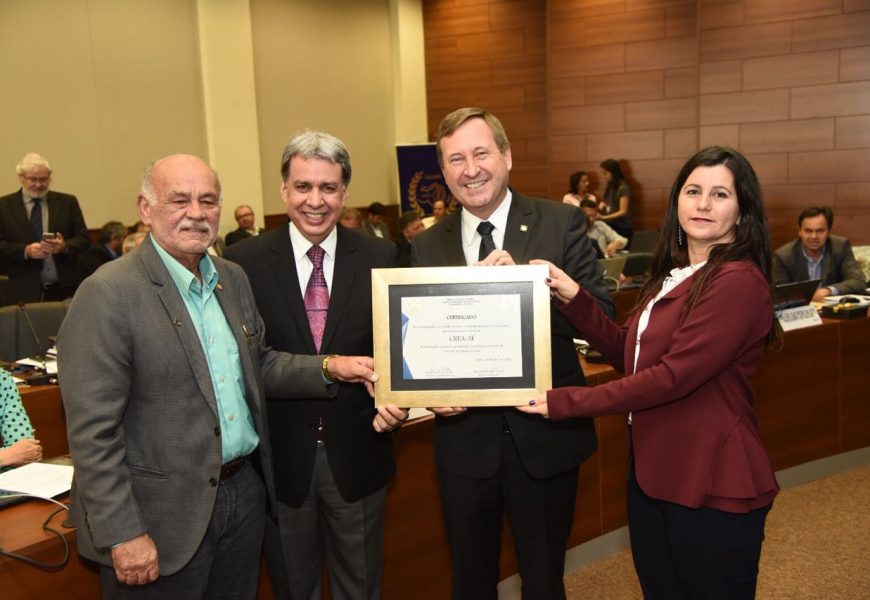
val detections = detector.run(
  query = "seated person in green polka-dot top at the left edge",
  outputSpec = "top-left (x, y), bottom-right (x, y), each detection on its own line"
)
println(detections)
top-left (0, 369), bottom-right (42, 470)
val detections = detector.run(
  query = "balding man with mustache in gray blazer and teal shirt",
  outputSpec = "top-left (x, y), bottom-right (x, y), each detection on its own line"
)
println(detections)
top-left (58, 155), bottom-right (376, 599)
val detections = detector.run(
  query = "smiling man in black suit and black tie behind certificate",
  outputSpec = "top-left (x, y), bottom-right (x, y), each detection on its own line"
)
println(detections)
top-left (412, 108), bottom-right (614, 600)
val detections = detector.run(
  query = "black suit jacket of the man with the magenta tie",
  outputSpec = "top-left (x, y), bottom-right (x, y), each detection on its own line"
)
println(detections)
top-left (226, 225), bottom-right (396, 506)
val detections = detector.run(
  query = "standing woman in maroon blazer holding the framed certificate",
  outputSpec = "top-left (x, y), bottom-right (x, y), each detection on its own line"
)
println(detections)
top-left (520, 147), bottom-right (779, 600)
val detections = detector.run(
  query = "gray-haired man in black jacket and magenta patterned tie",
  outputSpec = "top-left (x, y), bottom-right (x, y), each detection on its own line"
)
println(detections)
top-left (221, 131), bottom-right (407, 599)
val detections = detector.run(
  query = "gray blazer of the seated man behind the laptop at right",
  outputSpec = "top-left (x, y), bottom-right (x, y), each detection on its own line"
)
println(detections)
top-left (773, 235), bottom-right (867, 294)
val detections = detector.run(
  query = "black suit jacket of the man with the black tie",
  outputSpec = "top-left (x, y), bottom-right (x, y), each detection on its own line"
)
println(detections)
top-left (411, 192), bottom-right (614, 478)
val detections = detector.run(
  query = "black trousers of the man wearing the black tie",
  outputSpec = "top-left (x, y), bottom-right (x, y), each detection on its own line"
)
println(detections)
top-left (439, 426), bottom-right (579, 600)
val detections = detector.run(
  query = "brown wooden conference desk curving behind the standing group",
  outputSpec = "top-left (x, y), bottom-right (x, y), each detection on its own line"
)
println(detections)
top-left (0, 318), bottom-right (870, 600)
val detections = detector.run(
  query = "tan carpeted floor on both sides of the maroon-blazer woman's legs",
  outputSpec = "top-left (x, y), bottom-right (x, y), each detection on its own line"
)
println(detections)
top-left (565, 466), bottom-right (870, 600)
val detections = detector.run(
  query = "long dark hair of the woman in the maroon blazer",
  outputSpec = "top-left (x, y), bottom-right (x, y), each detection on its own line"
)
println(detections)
top-left (638, 146), bottom-right (775, 339)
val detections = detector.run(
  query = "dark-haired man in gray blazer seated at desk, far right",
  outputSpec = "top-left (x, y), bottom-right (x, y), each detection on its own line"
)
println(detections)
top-left (773, 206), bottom-right (867, 302)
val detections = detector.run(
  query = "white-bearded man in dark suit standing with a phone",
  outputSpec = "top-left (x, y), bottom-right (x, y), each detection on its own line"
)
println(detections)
top-left (0, 152), bottom-right (91, 304)
